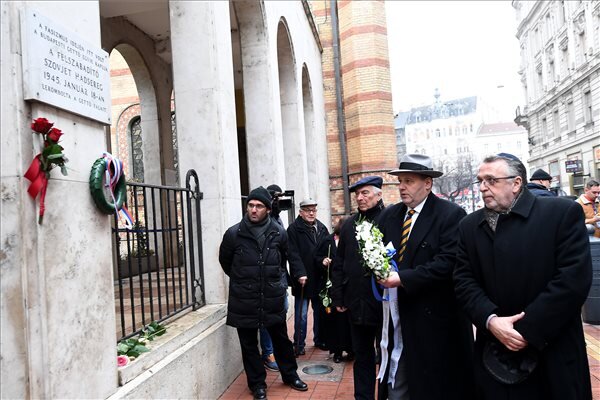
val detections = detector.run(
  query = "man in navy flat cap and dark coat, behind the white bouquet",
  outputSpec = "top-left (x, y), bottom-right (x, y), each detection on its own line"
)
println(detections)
top-left (331, 176), bottom-right (384, 399)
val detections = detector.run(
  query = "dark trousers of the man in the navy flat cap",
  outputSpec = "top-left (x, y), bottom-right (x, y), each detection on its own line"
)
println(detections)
top-left (350, 324), bottom-right (381, 400)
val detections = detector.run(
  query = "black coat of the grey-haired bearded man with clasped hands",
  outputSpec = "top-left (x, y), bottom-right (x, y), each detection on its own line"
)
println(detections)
top-left (454, 189), bottom-right (592, 400)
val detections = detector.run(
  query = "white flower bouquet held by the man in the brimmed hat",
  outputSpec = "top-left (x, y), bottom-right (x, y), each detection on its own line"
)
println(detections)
top-left (355, 219), bottom-right (396, 280)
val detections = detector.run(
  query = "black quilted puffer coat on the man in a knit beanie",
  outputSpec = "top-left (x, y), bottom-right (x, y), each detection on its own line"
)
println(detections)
top-left (219, 219), bottom-right (303, 328)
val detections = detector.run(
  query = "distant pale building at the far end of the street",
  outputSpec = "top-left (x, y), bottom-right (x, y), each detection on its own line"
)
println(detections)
top-left (396, 90), bottom-right (529, 212)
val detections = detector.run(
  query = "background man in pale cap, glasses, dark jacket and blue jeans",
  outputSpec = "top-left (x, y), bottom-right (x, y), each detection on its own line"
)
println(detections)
top-left (287, 199), bottom-right (329, 356)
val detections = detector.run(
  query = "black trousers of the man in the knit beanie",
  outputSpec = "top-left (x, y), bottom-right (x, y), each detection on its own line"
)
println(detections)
top-left (237, 322), bottom-right (298, 391)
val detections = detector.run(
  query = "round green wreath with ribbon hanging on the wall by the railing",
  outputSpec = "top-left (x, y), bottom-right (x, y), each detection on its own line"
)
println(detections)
top-left (90, 153), bottom-right (131, 229)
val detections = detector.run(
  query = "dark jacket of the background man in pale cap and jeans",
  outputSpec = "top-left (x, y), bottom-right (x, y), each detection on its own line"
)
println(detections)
top-left (287, 216), bottom-right (329, 299)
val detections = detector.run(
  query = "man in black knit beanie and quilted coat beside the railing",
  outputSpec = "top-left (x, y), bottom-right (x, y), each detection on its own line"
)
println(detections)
top-left (219, 186), bottom-right (308, 399)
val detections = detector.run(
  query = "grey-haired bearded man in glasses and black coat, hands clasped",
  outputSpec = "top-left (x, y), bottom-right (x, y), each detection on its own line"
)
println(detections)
top-left (454, 153), bottom-right (592, 400)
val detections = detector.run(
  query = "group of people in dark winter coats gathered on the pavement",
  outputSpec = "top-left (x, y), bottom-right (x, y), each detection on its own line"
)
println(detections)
top-left (219, 153), bottom-right (600, 400)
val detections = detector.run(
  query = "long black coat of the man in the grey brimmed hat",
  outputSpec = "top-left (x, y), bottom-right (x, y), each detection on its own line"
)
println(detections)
top-left (379, 193), bottom-right (474, 400)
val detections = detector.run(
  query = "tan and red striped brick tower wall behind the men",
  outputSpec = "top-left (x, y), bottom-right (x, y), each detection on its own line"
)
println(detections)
top-left (310, 1), bottom-right (399, 220)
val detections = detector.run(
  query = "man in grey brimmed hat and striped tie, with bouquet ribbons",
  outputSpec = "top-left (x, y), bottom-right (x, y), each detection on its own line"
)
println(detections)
top-left (378, 154), bottom-right (473, 400)
